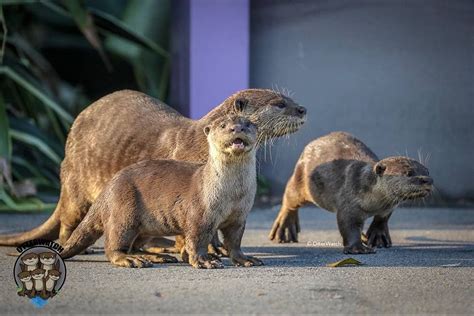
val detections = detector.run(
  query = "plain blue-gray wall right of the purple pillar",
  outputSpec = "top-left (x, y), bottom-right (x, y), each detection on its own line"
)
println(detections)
top-left (251, 0), bottom-right (474, 198)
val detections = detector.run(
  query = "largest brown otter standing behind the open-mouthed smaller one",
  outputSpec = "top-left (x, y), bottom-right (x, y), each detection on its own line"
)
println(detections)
top-left (0, 89), bottom-right (306, 246)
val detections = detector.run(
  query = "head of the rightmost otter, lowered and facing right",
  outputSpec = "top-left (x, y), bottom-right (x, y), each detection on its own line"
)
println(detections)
top-left (374, 157), bottom-right (433, 203)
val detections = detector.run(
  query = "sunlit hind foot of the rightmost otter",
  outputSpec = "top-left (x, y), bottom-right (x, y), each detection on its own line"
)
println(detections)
top-left (268, 211), bottom-right (300, 243)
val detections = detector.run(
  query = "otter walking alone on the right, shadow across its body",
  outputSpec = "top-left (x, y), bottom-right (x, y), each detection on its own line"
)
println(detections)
top-left (269, 132), bottom-right (433, 254)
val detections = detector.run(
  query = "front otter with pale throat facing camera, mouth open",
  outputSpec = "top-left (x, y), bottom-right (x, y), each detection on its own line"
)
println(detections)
top-left (61, 116), bottom-right (262, 269)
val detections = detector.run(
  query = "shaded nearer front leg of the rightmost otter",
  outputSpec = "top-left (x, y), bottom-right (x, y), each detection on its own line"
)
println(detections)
top-left (336, 210), bottom-right (375, 254)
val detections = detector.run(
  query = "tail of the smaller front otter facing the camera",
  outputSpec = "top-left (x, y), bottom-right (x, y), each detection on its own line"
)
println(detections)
top-left (61, 206), bottom-right (104, 259)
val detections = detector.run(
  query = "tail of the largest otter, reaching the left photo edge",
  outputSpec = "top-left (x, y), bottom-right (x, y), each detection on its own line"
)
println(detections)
top-left (0, 208), bottom-right (61, 246)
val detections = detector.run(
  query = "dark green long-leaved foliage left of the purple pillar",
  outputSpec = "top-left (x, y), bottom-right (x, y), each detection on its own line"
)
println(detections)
top-left (0, 0), bottom-right (170, 211)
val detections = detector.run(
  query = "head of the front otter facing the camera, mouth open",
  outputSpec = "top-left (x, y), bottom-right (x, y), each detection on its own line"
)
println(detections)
top-left (204, 115), bottom-right (257, 159)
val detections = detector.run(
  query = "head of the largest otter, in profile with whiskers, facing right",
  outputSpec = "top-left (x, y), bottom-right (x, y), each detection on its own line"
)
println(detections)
top-left (224, 89), bottom-right (306, 142)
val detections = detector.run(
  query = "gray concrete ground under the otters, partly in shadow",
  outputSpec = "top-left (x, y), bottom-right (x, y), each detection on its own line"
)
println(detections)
top-left (0, 208), bottom-right (474, 314)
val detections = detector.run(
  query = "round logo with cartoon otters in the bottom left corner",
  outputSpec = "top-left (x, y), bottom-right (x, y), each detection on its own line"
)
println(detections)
top-left (13, 246), bottom-right (66, 306)
